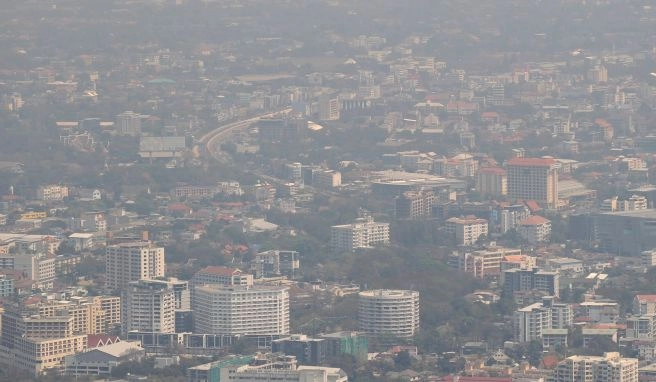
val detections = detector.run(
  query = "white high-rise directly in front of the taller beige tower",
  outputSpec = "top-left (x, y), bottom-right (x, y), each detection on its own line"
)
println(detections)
top-left (121, 280), bottom-right (176, 334)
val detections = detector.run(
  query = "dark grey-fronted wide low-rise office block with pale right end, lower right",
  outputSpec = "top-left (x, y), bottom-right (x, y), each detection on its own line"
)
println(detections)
top-left (503, 268), bottom-right (560, 297)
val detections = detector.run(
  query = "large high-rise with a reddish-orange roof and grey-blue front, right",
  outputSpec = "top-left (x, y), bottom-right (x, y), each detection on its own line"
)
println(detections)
top-left (506, 158), bottom-right (558, 208)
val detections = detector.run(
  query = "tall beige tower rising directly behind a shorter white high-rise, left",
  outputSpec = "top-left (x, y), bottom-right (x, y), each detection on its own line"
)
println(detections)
top-left (105, 241), bottom-right (165, 290)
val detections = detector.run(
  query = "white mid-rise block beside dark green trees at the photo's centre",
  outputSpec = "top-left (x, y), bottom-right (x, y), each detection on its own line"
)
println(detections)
top-left (330, 217), bottom-right (390, 252)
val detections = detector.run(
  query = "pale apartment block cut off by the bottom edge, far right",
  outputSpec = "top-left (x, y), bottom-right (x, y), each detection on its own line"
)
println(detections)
top-left (548, 352), bottom-right (638, 382)
